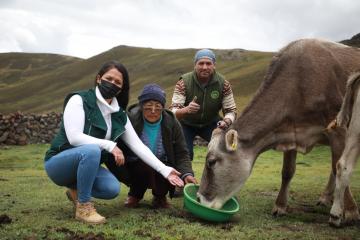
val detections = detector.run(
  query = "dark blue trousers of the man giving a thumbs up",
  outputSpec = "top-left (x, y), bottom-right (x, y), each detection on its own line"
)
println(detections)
top-left (181, 122), bottom-right (217, 160)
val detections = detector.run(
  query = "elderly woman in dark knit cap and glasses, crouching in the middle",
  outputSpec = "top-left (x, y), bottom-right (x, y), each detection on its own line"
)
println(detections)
top-left (107, 84), bottom-right (196, 208)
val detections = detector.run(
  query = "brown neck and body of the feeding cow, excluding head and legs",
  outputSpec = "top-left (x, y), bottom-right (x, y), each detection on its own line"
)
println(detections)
top-left (235, 39), bottom-right (360, 141)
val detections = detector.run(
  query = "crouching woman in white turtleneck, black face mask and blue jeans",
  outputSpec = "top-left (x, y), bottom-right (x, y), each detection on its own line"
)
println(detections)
top-left (45, 61), bottom-right (183, 224)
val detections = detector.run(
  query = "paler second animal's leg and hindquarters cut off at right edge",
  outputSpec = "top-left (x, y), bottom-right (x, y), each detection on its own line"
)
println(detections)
top-left (329, 72), bottom-right (360, 227)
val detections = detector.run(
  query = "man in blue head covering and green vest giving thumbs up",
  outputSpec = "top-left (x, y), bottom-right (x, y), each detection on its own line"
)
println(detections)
top-left (170, 49), bottom-right (236, 159)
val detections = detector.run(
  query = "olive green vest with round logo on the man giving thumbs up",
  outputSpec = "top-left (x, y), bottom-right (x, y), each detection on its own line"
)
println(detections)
top-left (180, 71), bottom-right (225, 127)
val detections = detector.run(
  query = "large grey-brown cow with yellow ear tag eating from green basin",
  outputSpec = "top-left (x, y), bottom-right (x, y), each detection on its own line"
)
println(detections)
top-left (198, 39), bottom-right (360, 219)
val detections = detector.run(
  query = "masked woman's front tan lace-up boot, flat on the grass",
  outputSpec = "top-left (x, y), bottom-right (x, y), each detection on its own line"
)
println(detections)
top-left (75, 202), bottom-right (106, 224)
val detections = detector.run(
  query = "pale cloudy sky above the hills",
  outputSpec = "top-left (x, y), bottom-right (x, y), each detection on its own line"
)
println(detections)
top-left (0, 0), bottom-right (360, 58)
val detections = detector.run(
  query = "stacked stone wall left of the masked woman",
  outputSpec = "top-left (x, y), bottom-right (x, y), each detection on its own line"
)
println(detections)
top-left (0, 112), bottom-right (62, 145)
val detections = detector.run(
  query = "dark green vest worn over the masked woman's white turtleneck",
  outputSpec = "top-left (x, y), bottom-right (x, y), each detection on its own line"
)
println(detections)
top-left (45, 89), bottom-right (127, 162)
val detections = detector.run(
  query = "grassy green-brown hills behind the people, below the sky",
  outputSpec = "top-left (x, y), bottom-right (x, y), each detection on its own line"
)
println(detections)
top-left (0, 34), bottom-right (359, 113)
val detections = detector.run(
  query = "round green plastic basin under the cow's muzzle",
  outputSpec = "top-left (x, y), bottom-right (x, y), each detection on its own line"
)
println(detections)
top-left (184, 184), bottom-right (239, 222)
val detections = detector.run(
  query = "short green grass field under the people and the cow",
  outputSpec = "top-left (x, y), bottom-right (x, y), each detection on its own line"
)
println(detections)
top-left (0, 145), bottom-right (360, 240)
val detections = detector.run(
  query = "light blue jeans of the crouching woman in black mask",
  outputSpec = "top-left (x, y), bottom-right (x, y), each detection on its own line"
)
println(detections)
top-left (45, 144), bottom-right (120, 203)
